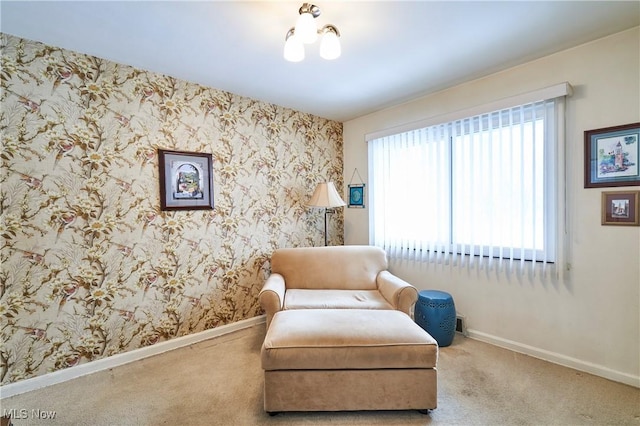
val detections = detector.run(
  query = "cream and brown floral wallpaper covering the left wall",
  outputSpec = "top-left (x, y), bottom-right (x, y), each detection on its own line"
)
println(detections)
top-left (0, 34), bottom-right (343, 384)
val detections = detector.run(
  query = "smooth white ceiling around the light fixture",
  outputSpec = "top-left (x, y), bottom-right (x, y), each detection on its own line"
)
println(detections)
top-left (0, 0), bottom-right (640, 121)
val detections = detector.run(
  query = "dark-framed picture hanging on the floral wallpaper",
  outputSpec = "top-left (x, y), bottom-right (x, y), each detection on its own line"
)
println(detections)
top-left (158, 149), bottom-right (213, 210)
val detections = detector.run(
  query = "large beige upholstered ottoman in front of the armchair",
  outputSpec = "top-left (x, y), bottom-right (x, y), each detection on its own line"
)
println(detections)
top-left (261, 309), bottom-right (438, 413)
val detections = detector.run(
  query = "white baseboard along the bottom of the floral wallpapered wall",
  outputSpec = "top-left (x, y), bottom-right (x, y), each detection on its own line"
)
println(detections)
top-left (0, 315), bottom-right (266, 398)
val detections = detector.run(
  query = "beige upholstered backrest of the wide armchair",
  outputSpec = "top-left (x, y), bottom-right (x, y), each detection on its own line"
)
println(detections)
top-left (271, 246), bottom-right (389, 290)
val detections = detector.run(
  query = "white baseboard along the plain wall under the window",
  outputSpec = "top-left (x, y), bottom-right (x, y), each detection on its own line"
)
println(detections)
top-left (467, 329), bottom-right (640, 388)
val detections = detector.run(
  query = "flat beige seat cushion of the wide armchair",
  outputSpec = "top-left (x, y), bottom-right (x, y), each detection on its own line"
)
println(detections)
top-left (284, 289), bottom-right (394, 310)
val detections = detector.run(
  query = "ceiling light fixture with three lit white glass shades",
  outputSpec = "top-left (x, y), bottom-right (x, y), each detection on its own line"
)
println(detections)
top-left (284, 3), bottom-right (341, 62)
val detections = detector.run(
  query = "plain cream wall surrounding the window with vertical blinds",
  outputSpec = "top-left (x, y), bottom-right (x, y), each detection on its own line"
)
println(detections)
top-left (343, 27), bottom-right (640, 387)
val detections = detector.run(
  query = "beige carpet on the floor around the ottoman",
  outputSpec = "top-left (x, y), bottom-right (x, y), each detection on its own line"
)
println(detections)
top-left (1, 324), bottom-right (640, 426)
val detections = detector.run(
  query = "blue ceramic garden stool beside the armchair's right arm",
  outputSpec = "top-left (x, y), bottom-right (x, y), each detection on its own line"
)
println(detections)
top-left (414, 290), bottom-right (456, 346)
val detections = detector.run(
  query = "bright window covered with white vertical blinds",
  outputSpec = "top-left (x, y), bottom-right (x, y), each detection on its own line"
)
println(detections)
top-left (368, 86), bottom-right (563, 274)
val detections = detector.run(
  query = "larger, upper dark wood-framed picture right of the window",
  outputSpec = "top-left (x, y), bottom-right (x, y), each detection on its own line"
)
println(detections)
top-left (584, 123), bottom-right (640, 188)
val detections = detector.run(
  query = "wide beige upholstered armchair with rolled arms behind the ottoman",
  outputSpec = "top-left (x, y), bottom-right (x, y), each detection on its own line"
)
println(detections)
top-left (259, 246), bottom-right (418, 327)
